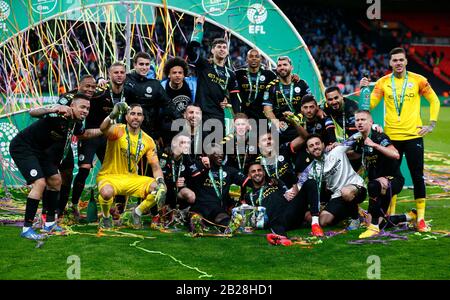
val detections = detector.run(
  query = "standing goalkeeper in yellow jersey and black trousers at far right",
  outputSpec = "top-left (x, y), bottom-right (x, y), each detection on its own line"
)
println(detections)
top-left (360, 48), bottom-right (440, 232)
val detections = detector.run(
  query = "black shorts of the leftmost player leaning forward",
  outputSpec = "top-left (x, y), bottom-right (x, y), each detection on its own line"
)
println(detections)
top-left (9, 138), bottom-right (59, 184)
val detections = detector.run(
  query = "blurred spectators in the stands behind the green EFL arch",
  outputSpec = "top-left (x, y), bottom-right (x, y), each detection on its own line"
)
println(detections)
top-left (22, 6), bottom-right (389, 94)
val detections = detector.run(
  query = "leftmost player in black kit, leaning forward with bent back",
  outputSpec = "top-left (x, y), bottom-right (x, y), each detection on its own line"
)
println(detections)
top-left (9, 94), bottom-right (101, 240)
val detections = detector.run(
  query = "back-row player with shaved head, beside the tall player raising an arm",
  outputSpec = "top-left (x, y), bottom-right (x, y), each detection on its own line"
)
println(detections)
top-left (236, 48), bottom-right (277, 120)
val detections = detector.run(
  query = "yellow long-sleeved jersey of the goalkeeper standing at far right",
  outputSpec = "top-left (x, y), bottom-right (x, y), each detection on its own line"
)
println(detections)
top-left (370, 71), bottom-right (440, 141)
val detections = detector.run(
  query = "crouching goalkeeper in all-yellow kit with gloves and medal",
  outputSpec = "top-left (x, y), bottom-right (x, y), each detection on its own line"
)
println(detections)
top-left (97, 102), bottom-right (167, 228)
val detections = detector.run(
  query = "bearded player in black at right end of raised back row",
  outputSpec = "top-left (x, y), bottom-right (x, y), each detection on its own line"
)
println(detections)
top-left (263, 56), bottom-right (311, 143)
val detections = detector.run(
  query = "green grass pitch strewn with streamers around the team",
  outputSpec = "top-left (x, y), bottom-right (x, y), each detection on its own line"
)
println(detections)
top-left (0, 107), bottom-right (450, 280)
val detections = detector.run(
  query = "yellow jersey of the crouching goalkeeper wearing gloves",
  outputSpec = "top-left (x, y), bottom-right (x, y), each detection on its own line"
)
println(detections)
top-left (98, 124), bottom-right (158, 176)
